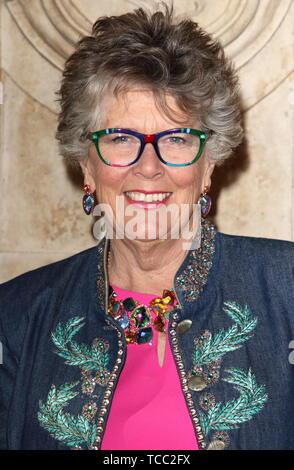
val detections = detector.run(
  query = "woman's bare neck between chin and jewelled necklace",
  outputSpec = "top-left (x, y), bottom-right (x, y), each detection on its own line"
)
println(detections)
top-left (108, 239), bottom-right (187, 296)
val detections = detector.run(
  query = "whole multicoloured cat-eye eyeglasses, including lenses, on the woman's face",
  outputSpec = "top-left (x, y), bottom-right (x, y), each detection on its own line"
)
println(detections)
top-left (85, 128), bottom-right (211, 167)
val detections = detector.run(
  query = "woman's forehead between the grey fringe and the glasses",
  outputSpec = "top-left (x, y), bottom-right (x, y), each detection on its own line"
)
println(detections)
top-left (101, 88), bottom-right (192, 127)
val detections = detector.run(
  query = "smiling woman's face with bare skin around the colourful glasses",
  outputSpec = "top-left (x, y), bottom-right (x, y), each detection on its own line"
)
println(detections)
top-left (81, 90), bottom-right (214, 241)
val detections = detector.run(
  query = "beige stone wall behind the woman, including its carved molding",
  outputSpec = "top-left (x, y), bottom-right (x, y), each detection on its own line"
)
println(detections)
top-left (0, 0), bottom-right (294, 281)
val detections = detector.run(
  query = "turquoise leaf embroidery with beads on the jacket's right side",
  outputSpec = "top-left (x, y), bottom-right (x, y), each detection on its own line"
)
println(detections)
top-left (188, 302), bottom-right (268, 450)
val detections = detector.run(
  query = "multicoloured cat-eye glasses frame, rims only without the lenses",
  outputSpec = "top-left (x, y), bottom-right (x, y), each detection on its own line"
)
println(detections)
top-left (84, 127), bottom-right (212, 167)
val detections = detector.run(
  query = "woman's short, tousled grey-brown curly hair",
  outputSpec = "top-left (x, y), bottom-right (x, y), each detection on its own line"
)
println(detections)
top-left (56, 4), bottom-right (243, 164)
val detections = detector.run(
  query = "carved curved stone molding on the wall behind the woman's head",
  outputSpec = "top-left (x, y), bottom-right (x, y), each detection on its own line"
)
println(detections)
top-left (3, 0), bottom-right (293, 112)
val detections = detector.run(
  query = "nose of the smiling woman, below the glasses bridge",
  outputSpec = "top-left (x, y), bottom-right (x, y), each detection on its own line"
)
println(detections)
top-left (133, 142), bottom-right (164, 179)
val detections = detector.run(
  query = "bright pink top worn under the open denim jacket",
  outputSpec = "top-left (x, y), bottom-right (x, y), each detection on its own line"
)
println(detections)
top-left (101, 286), bottom-right (198, 450)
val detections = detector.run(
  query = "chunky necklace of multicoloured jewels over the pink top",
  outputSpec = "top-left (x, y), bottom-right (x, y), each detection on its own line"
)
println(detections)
top-left (108, 250), bottom-right (177, 344)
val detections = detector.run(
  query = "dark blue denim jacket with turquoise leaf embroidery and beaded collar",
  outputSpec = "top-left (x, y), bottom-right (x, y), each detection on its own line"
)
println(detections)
top-left (0, 221), bottom-right (294, 450)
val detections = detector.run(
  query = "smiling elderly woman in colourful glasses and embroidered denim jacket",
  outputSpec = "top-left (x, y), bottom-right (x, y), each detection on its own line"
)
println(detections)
top-left (0, 4), bottom-right (294, 450)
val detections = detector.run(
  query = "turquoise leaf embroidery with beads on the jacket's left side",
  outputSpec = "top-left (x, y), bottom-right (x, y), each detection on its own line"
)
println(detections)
top-left (37, 317), bottom-right (110, 449)
